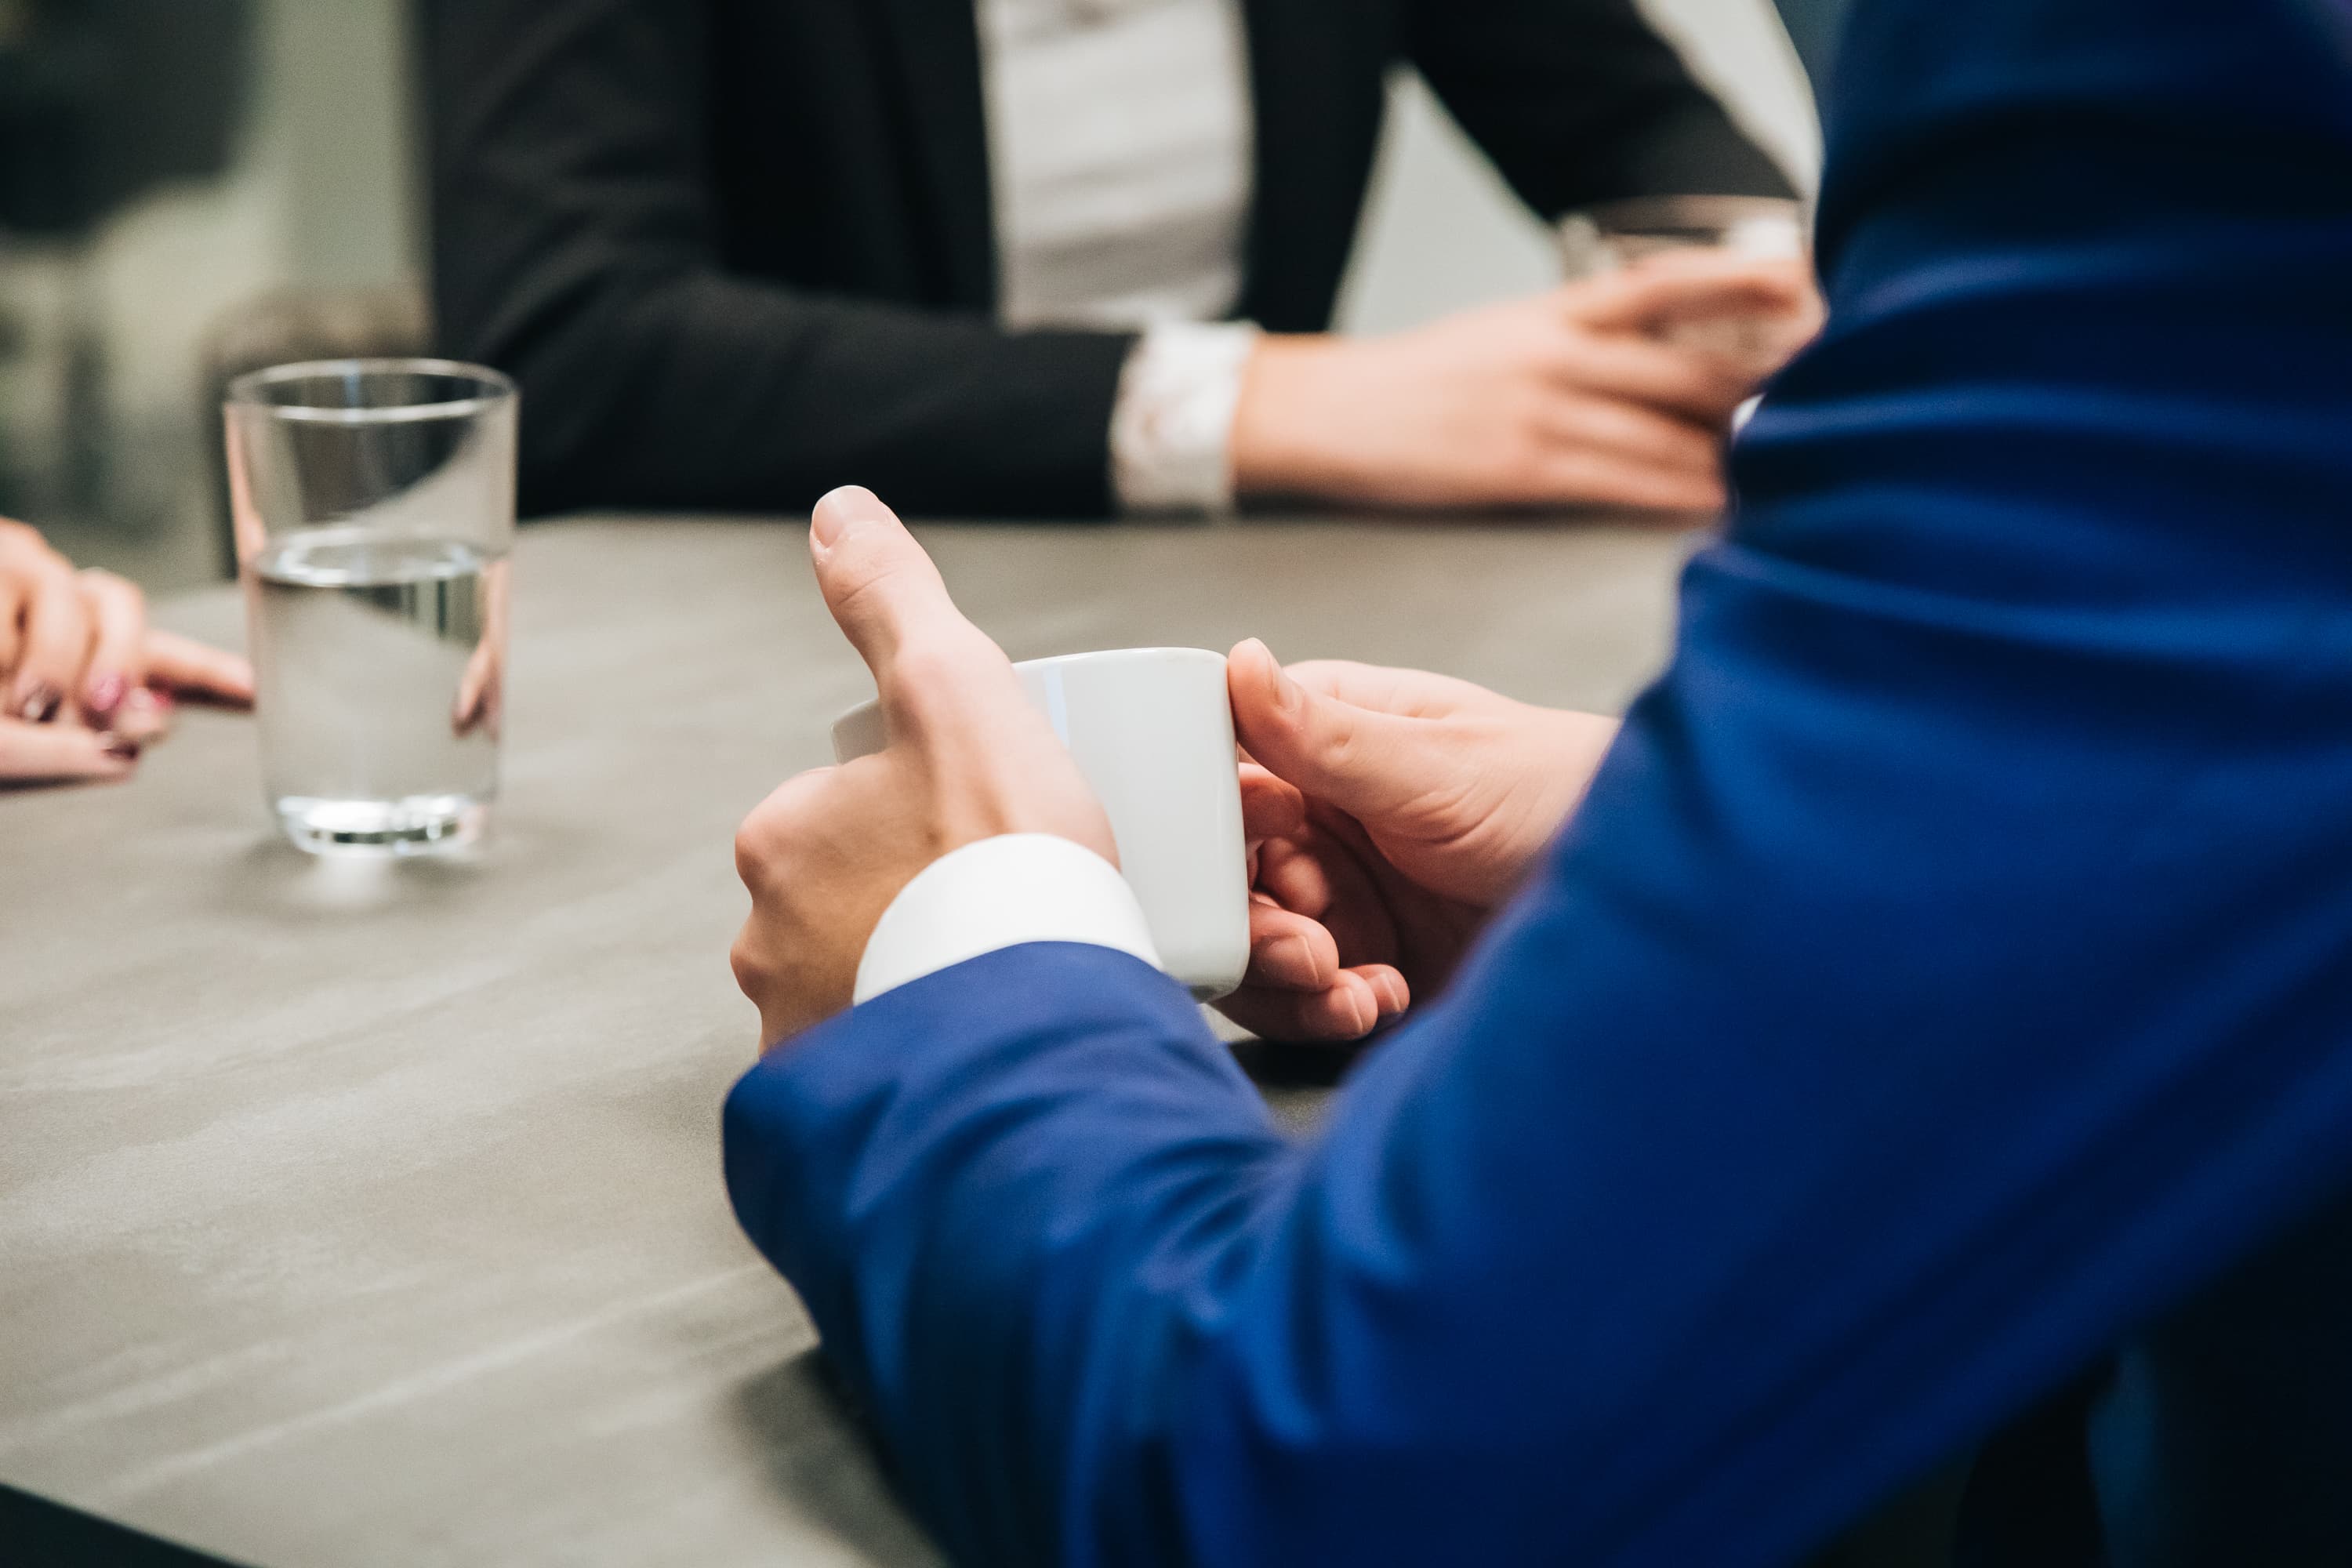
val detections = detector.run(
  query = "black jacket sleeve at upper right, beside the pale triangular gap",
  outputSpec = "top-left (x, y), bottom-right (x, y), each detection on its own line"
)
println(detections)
top-left (1406, 0), bottom-right (1790, 219)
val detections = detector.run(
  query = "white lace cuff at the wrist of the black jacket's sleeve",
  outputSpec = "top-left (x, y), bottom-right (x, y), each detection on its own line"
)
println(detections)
top-left (1110, 322), bottom-right (1258, 513)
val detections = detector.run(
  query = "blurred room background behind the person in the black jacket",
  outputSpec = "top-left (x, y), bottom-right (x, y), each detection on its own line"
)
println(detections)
top-left (0, 0), bottom-right (1820, 590)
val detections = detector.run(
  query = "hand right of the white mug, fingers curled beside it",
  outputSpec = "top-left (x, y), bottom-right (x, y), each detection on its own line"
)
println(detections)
top-left (1218, 640), bottom-right (1618, 1039)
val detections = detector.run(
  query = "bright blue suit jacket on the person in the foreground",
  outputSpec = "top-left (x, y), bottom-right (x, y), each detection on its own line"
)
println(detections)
top-left (727, 0), bottom-right (2352, 1568)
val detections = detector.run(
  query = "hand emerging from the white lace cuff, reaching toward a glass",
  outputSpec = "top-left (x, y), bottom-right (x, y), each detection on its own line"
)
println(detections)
top-left (1232, 254), bottom-right (1820, 513)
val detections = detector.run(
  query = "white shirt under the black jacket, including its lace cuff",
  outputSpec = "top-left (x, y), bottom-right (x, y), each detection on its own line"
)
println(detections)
top-left (978, 0), bottom-right (1256, 513)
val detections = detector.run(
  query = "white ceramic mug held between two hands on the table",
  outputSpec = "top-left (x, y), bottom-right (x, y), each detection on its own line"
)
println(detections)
top-left (833, 649), bottom-right (1249, 1001)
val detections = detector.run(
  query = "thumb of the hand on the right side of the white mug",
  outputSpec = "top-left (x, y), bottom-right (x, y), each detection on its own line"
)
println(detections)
top-left (1225, 637), bottom-right (1451, 825)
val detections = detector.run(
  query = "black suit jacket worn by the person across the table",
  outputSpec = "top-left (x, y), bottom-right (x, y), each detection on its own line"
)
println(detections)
top-left (423, 0), bottom-right (1785, 515)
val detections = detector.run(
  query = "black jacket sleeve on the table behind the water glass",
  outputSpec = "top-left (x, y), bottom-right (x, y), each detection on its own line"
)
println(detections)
top-left (421, 0), bottom-right (1131, 526)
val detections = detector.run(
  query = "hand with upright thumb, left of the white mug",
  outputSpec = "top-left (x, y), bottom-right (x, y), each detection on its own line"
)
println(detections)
top-left (734, 487), bottom-right (1117, 1048)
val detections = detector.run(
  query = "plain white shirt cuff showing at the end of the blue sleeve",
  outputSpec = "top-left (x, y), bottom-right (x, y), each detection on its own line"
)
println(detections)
top-left (851, 832), bottom-right (1160, 1001)
